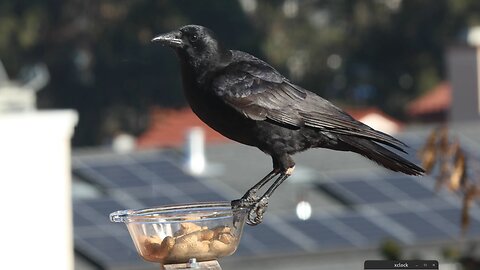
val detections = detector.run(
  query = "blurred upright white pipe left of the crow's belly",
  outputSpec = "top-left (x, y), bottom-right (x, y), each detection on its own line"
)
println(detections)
top-left (185, 127), bottom-right (207, 175)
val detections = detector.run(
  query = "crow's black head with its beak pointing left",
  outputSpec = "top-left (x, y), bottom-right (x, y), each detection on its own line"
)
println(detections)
top-left (152, 25), bottom-right (230, 67)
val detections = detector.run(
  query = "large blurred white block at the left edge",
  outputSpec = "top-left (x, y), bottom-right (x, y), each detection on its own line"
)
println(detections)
top-left (0, 110), bottom-right (77, 270)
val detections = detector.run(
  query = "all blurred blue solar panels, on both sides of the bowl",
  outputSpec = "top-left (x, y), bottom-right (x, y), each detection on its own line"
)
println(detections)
top-left (73, 146), bottom-right (480, 269)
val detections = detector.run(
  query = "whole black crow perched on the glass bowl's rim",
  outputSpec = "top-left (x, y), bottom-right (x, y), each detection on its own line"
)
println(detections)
top-left (152, 25), bottom-right (424, 225)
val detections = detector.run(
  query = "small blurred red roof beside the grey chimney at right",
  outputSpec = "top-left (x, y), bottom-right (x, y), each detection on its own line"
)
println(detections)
top-left (406, 82), bottom-right (452, 116)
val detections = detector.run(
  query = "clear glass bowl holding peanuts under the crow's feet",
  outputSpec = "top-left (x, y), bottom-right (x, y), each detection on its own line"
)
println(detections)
top-left (110, 202), bottom-right (247, 264)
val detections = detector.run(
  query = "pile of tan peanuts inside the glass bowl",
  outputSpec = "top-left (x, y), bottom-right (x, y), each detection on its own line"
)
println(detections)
top-left (142, 223), bottom-right (236, 263)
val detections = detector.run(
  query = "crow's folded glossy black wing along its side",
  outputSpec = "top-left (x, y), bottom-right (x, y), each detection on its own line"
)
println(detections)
top-left (212, 52), bottom-right (405, 151)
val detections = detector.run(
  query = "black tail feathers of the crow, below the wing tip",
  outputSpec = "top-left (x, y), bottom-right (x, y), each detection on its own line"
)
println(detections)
top-left (340, 136), bottom-right (425, 175)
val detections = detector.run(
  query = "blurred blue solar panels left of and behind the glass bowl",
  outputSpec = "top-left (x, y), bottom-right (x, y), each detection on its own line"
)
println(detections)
top-left (73, 153), bottom-right (233, 269)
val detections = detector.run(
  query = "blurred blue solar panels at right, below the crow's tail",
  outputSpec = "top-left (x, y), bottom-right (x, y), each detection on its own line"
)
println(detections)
top-left (308, 176), bottom-right (480, 250)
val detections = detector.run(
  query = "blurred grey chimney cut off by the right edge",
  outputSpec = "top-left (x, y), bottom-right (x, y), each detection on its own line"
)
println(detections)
top-left (447, 28), bottom-right (480, 122)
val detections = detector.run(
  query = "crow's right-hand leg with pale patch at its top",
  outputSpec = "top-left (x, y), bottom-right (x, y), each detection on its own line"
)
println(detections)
top-left (247, 166), bottom-right (295, 226)
